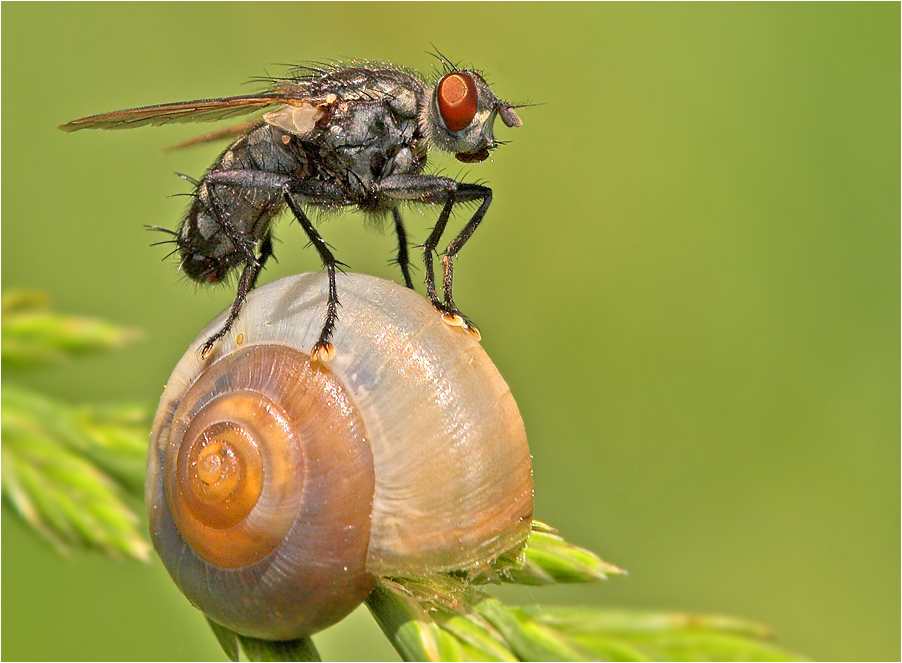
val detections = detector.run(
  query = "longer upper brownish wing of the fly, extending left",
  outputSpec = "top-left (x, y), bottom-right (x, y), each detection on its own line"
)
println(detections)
top-left (60, 85), bottom-right (330, 132)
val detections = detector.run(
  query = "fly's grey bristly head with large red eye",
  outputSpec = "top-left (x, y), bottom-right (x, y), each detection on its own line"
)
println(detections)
top-left (421, 70), bottom-right (522, 163)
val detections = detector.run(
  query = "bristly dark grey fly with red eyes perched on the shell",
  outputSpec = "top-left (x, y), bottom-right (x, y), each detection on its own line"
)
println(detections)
top-left (60, 58), bottom-right (521, 361)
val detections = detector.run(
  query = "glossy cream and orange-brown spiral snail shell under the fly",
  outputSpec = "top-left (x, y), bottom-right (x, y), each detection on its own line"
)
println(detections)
top-left (146, 274), bottom-right (533, 640)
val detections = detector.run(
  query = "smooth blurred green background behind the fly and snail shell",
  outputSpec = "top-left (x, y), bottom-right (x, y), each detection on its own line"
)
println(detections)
top-left (2, 3), bottom-right (900, 660)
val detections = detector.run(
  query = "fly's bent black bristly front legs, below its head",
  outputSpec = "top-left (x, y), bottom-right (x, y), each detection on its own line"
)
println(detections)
top-left (379, 175), bottom-right (492, 338)
